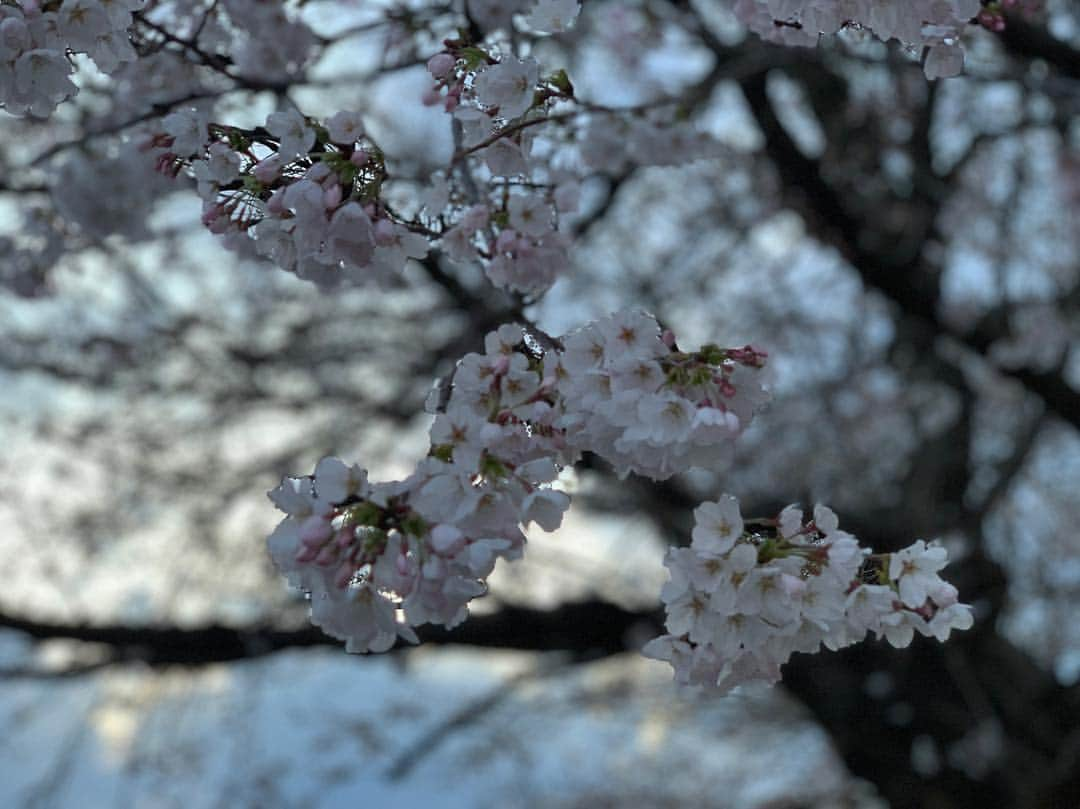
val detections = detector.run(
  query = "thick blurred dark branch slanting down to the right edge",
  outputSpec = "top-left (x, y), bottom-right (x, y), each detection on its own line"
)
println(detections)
top-left (741, 72), bottom-right (1080, 436)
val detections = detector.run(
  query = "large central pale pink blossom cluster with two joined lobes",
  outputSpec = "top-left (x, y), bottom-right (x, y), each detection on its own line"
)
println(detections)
top-left (269, 312), bottom-right (761, 651)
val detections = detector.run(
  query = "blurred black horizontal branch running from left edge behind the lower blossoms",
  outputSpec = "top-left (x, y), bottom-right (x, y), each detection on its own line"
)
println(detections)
top-left (0, 601), bottom-right (662, 666)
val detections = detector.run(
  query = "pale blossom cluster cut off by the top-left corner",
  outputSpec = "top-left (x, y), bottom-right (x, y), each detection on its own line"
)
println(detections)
top-left (0, 0), bottom-right (143, 118)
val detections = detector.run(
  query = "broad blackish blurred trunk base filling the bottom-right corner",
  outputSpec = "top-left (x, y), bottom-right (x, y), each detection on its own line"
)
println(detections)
top-left (784, 604), bottom-right (1080, 809)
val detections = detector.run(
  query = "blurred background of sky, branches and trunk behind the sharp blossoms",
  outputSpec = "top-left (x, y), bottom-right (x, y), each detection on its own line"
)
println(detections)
top-left (0, 0), bottom-right (1080, 809)
